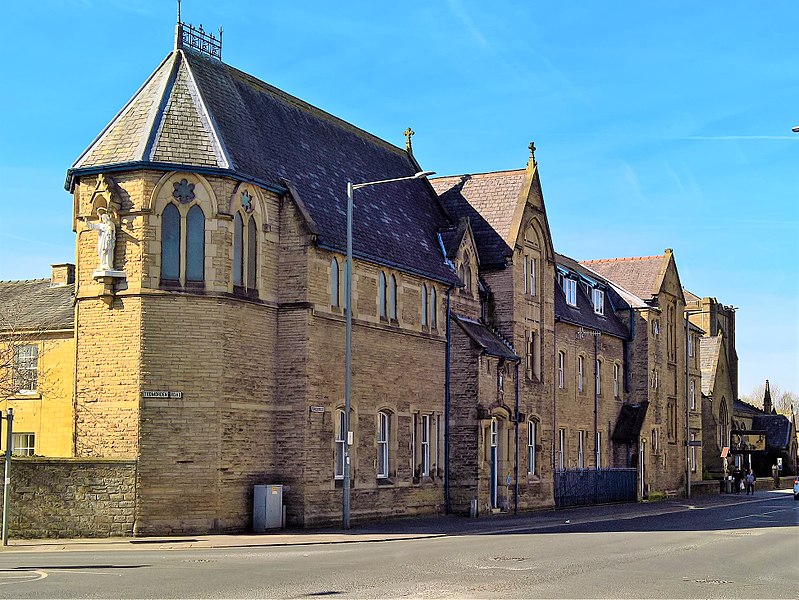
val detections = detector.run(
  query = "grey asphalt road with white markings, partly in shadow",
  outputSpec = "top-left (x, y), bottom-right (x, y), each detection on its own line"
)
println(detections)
top-left (0, 492), bottom-right (799, 598)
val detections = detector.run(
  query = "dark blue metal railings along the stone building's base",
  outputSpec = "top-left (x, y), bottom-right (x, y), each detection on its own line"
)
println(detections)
top-left (555, 469), bottom-right (638, 508)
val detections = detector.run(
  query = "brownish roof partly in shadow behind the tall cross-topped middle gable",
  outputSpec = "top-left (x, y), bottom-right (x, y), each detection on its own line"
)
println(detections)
top-left (430, 169), bottom-right (526, 268)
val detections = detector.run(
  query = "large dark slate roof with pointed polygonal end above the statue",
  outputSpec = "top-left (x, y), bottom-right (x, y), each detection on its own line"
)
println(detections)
top-left (67, 45), bottom-right (457, 283)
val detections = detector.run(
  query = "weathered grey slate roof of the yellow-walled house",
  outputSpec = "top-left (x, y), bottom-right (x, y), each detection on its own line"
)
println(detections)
top-left (0, 279), bottom-right (75, 331)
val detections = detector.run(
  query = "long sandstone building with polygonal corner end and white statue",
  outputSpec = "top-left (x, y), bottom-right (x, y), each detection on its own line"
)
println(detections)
top-left (0, 25), bottom-right (728, 535)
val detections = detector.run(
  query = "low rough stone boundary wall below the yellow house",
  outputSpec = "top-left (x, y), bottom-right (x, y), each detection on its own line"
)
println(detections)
top-left (0, 457), bottom-right (136, 539)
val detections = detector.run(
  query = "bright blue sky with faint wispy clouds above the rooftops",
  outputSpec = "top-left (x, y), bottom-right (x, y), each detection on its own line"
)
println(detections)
top-left (0, 0), bottom-right (799, 393)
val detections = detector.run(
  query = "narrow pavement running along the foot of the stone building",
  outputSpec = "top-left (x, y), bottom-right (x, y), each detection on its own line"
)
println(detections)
top-left (0, 489), bottom-right (792, 553)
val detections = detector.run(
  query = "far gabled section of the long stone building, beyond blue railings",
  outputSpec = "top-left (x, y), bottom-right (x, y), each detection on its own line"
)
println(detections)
top-left (580, 249), bottom-right (702, 495)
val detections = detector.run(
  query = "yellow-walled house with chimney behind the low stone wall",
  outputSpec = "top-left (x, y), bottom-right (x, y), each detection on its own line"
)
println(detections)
top-left (0, 264), bottom-right (75, 457)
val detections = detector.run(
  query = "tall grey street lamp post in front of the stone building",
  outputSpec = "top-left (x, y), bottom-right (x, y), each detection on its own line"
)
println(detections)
top-left (342, 171), bottom-right (435, 529)
